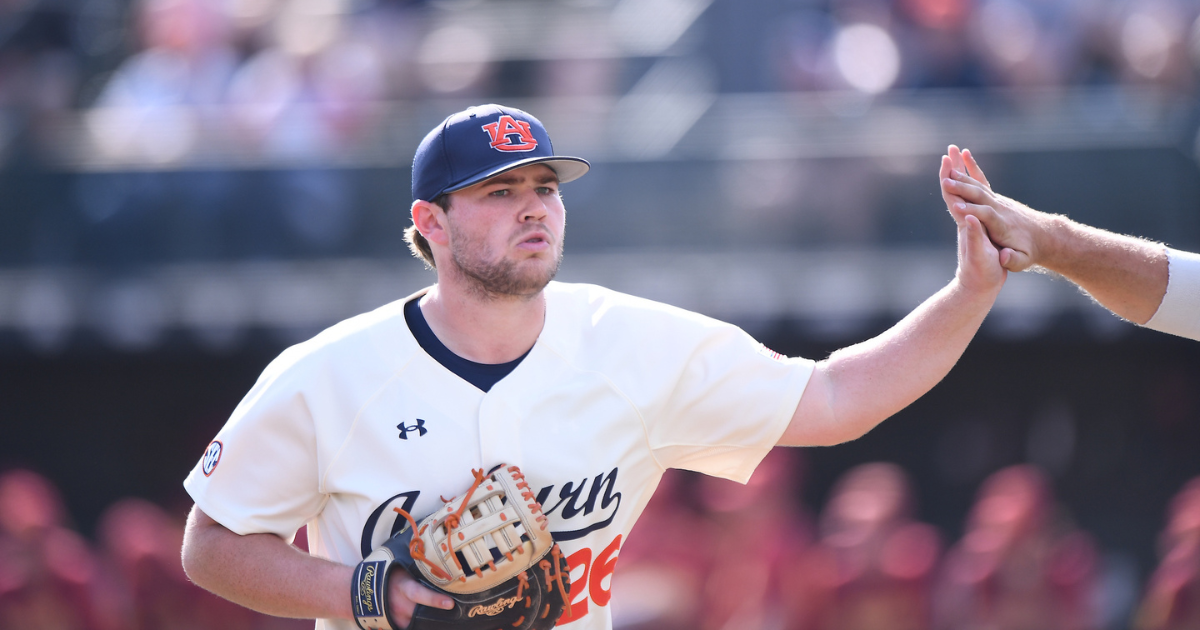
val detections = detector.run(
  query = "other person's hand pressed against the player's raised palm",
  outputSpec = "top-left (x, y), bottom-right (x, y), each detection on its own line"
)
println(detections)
top-left (940, 145), bottom-right (1054, 271)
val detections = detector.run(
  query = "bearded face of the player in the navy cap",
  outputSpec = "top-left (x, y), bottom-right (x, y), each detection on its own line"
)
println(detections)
top-left (446, 164), bottom-right (566, 296)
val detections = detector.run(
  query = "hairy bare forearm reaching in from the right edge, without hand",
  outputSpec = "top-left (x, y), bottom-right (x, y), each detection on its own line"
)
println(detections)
top-left (1038, 217), bottom-right (1168, 324)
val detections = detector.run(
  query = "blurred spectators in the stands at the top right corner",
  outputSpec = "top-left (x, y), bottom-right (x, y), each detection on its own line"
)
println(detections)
top-left (776, 0), bottom-right (1200, 96)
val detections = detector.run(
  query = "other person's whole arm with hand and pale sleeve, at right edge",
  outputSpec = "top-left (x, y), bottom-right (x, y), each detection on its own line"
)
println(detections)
top-left (941, 145), bottom-right (1200, 340)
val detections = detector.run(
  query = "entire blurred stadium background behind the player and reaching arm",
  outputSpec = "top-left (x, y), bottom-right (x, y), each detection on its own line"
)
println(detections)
top-left (0, 0), bottom-right (1200, 630)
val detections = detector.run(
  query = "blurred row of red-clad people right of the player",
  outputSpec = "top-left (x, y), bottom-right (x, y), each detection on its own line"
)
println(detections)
top-left (612, 449), bottom-right (1200, 630)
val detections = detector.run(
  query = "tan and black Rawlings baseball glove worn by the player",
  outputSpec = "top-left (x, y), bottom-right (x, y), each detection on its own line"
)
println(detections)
top-left (350, 464), bottom-right (571, 630)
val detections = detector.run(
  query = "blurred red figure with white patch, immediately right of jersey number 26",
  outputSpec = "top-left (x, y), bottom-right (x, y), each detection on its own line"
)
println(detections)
top-left (612, 469), bottom-right (712, 630)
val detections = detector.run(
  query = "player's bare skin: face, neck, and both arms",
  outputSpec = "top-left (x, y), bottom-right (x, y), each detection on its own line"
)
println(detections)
top-left (184, 154), bottom-right (1006, 625)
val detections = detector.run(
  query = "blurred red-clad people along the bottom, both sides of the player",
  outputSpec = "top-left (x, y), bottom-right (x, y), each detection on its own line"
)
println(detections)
top-left (0, 456), bottom-right (1200, 630)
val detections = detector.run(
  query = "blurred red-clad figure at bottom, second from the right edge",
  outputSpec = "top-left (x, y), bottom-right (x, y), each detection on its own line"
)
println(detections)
top-left (935, 466), bottom-right (1098, 630)
